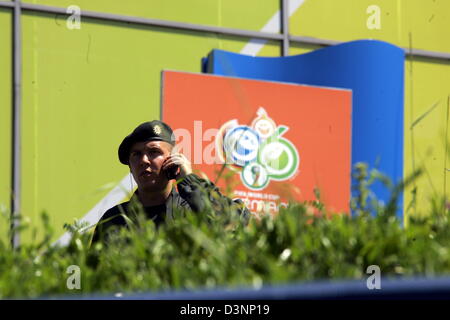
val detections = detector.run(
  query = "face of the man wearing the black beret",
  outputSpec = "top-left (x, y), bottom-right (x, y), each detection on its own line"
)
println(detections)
top-left (129, 141), bottom-right (172, 191)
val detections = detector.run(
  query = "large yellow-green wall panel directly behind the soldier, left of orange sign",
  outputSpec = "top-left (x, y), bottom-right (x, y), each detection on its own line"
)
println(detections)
top-left (22, 13), bottom-right (275, 241)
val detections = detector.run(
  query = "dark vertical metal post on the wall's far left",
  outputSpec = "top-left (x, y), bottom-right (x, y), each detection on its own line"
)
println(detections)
top-left (11, 0), bottom-right (22, 248)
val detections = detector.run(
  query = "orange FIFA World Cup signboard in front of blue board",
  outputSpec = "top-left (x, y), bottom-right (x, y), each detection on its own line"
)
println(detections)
top-left (161, 71), bottom-right (352, 213)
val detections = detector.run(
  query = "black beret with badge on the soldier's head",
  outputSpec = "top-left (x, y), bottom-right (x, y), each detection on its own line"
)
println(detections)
top-left (119, 120), bottom-right (175, 164)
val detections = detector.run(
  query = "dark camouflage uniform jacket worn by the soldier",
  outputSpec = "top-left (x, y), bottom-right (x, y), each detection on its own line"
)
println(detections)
top-left (92, 174), bottom-right (250, 243)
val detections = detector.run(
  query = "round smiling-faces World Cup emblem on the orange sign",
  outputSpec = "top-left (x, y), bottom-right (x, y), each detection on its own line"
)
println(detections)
top-left (216, 107), bottom-right (300, 190)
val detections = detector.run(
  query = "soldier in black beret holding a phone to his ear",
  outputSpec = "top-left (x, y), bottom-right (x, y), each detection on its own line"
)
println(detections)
top-left (93, 120), bottom-right (250, 243)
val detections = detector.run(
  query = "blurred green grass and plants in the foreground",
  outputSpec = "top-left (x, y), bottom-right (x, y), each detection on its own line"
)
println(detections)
top-left (0, 165), bottom-right (450, 298)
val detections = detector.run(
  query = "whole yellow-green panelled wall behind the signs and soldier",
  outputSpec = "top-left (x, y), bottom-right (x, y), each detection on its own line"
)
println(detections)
top-left (0, 0), bottom-right (450, 241)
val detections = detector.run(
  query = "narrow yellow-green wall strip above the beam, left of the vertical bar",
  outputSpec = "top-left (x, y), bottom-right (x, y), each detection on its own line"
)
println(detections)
top-left (24, 0), bottom-right (280, 31)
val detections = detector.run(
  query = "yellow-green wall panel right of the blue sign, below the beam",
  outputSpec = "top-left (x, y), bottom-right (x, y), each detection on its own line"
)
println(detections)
top-left (404, 59), bottom-right (450, 220)
